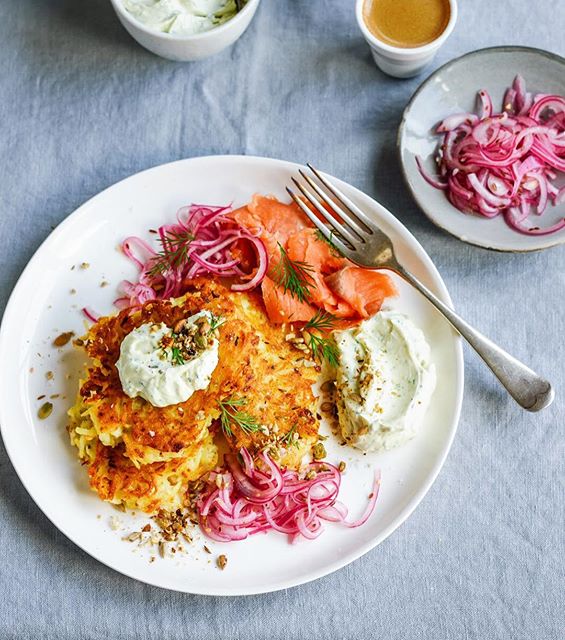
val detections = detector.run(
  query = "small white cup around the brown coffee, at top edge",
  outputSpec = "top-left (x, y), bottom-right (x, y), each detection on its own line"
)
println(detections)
top-left (355, 0), bottom-right (457, 78)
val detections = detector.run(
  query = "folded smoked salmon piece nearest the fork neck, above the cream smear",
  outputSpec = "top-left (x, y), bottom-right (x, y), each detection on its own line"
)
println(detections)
top-left (325, 266), bottom-right (396, 318)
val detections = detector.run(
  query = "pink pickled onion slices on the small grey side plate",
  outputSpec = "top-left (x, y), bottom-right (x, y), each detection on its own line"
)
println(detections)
top-left (416, 75), bottom-right (565, 235)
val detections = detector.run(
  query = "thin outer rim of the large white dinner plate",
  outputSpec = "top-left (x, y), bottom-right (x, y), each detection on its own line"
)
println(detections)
top-left (0, 155), bottom-right (464, 596)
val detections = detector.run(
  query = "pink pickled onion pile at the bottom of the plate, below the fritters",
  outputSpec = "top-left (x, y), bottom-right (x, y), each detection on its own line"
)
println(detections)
top-left (196, 449), bottom-right (380, 542)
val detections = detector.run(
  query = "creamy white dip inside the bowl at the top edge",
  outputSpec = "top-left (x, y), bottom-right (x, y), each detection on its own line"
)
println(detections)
top-left (123, 0), bottom-right (242, 36)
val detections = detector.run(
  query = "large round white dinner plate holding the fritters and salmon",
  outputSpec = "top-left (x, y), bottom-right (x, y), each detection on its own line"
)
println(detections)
top-left (0, 156), bottom-right (463, 595)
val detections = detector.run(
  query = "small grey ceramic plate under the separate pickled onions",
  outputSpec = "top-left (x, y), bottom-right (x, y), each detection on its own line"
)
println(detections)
top-left (398, 47), bottom-right (565, 251)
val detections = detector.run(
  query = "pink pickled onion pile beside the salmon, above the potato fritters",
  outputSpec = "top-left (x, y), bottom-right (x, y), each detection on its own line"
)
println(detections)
top-left (115, 204), bottom-right (268, 309)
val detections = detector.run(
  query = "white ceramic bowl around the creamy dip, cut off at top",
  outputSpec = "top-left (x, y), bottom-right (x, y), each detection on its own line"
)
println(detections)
top-left (110, 0), bottom-right (261, 62)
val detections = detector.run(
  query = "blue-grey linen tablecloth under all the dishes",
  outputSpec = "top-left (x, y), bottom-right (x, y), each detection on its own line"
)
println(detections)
top-left (0, 0), bottom-right (565, 640)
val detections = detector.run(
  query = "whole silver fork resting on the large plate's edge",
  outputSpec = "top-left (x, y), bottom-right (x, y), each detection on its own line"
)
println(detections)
top-left (287, 164), bottom-right (554, 411)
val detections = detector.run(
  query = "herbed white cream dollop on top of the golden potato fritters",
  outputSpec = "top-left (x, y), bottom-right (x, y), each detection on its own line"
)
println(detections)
top-left (116, 311), bottom-right (219, 407)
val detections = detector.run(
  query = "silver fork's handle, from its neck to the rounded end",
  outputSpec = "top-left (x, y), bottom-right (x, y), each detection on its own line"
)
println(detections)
top-left (395, 267), bottom-right (554, 411)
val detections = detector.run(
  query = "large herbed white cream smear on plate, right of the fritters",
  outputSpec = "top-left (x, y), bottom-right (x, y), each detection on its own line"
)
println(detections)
top-left (334, 311), bottom-right (436, 451)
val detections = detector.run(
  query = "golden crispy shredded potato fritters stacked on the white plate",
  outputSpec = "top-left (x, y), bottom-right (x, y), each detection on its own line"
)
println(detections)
top-left (69, 279), bottom-right (319, 513)
